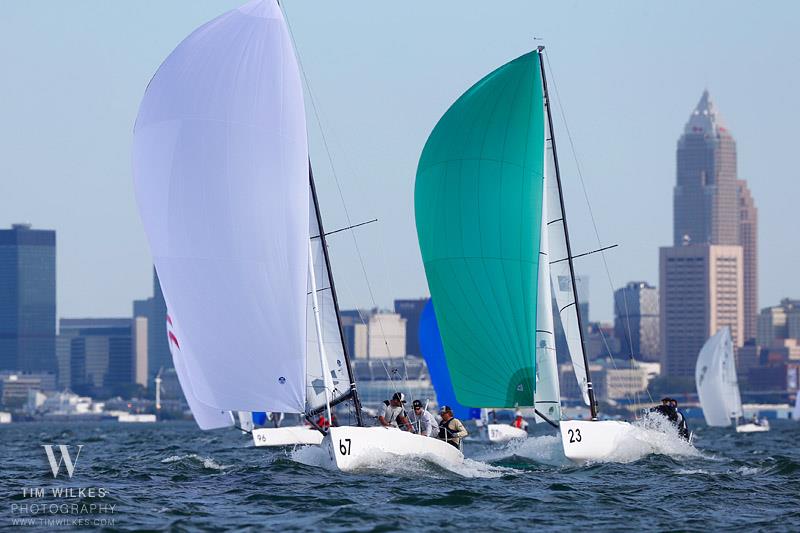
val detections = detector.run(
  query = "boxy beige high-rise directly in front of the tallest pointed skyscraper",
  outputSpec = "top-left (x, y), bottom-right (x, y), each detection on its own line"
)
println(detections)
top-left (659, 244), bottom-right (744, 378)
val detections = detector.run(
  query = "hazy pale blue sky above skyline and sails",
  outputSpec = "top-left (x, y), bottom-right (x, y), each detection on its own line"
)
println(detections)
top-left (0, 0), bottom-right (800, 320)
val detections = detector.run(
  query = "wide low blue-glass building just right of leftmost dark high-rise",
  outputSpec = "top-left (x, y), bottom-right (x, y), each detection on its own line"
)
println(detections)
top-left (58, 318), bottom-right (135, 396)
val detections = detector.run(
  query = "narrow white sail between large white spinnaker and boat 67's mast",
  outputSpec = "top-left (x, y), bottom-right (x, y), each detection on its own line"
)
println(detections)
top-left (306, 198), bottom-right (350, 411)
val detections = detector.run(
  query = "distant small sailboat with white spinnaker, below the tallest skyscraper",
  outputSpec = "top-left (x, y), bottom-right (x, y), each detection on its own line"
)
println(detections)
top-left (694, 326), bottom-right (769, 433)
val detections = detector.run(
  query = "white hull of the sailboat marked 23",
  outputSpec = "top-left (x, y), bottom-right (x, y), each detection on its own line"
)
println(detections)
top-left (559, 420), bottom-right (633, 461)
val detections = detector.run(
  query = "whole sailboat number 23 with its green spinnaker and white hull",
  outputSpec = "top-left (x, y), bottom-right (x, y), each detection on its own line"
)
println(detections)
top-left (414, 47), bottom-right (633, 461)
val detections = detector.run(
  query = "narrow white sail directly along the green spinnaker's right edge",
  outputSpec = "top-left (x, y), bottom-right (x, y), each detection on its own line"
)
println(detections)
top-left (533, 155), bottom-right (561, 422)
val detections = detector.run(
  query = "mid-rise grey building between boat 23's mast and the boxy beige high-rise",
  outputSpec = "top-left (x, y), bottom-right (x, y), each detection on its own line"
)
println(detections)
top-left (614, 281), bottom-right (661, 361)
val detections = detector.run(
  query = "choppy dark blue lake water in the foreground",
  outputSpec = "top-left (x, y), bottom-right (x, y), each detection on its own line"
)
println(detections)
top-left (0, 422), bottom-right (800, 532)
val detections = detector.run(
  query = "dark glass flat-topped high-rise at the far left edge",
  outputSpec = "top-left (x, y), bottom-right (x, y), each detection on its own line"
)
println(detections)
top-left (0, 224), bottom-right (58, 374)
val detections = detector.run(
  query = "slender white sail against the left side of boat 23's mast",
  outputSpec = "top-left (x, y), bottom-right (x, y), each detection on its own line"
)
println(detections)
top-left (544, 116), bottom-right (589, 405)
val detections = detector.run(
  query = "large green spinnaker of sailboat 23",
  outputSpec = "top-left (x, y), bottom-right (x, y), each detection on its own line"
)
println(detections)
top-left (414, 52), bottom-right (545, 407)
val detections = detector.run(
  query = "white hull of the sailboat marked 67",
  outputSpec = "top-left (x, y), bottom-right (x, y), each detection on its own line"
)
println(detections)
top-left (322, 426), bottom-right (464, 472)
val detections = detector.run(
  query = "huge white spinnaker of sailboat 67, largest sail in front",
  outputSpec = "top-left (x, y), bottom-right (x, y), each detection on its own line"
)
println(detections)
top-left (133, 0), bottom-right (309, 413)
